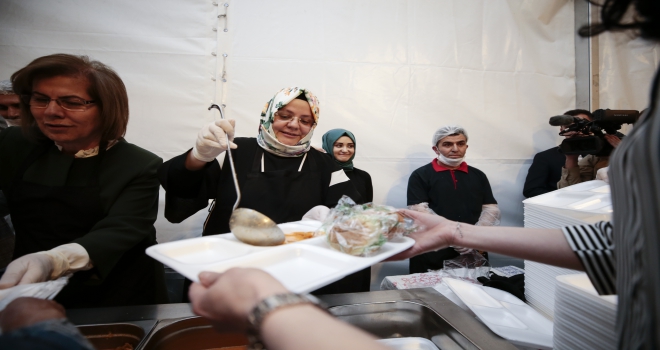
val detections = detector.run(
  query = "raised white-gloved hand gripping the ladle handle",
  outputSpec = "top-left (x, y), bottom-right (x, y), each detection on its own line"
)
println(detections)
top-left (192, 119), bottom-right (237, 162)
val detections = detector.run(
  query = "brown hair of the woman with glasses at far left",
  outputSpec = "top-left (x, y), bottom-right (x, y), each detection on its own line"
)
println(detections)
top-left (11, 54), bottom-right (128, 144)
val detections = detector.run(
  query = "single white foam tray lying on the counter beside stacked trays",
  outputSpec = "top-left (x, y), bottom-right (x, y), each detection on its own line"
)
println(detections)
top-left (444, 278), bottom-right (553, 349)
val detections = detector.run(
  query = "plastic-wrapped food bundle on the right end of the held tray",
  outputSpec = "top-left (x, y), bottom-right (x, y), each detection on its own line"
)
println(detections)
top-left (319, 196), bottom-right (415, 256)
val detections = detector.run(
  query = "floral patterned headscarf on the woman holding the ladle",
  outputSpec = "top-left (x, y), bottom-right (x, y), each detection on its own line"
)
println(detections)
top-left (257, 87), bottom-right (319, 157)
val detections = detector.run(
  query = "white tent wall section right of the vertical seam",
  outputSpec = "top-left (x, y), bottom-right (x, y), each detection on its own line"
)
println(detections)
top-left (220, 0), bottom-right (575, 237)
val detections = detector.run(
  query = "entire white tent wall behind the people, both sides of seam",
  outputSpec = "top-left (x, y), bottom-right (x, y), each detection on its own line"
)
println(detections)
top-left (0, 0), bottom-right (657, 242)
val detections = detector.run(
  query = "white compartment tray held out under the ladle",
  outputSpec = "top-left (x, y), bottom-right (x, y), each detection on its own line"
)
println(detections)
top-left (147, 221), bottom-right (415, 293)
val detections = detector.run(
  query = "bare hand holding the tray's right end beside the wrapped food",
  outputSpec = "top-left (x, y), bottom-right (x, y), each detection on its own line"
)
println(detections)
top-left (387, 209), bottom-right (456, 261)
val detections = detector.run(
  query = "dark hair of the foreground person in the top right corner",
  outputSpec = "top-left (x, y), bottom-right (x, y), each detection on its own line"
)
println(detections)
top-left (578, 0), bottom-right (660, 41)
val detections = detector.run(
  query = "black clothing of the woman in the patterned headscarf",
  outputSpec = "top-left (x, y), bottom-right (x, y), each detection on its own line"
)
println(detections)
top-left (158, 137), bottom-right (362, 235)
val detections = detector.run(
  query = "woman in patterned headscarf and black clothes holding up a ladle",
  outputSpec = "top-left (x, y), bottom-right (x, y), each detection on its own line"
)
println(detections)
top-left (159, 87), bottom-right (360, 235)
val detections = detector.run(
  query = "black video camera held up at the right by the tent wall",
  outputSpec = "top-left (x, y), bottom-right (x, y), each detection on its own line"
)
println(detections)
top-left (550, 109), bottom-right (639, 157)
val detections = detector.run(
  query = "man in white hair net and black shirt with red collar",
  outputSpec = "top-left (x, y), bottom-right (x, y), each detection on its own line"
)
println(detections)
top-left (408, 125), bottom-right (500, 273)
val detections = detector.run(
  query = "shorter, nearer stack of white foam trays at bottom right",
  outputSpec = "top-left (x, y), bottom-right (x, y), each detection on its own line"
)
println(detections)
top-left (553, 274), bottom-right (617, 349)
